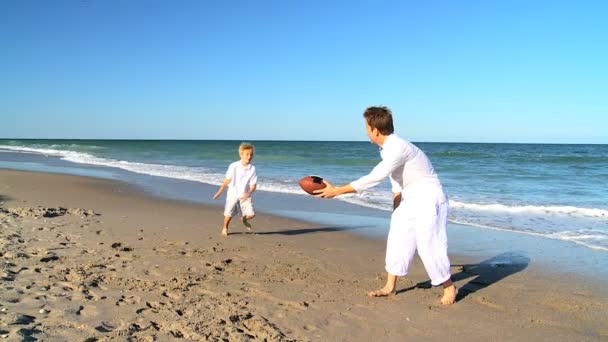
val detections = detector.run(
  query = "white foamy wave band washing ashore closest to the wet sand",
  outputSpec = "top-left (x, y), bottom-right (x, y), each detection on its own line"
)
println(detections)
top-left (0, 145), bottom-right (608, 251)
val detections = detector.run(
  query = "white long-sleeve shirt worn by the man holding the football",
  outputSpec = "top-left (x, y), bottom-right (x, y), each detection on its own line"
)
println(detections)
top-left (350, 134), bottom-right (441, 193)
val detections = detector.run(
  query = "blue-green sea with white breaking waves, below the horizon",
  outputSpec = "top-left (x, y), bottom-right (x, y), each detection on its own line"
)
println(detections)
top-left (0, 139), bottom-right (608, 278)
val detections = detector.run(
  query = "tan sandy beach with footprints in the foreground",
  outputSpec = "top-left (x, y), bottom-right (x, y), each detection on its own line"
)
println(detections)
top-left (0, 170), bottom-right (608, 341)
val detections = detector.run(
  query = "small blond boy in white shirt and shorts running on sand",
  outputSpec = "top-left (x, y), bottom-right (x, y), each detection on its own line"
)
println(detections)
top-left (213, 143), bottom-right (258, 236)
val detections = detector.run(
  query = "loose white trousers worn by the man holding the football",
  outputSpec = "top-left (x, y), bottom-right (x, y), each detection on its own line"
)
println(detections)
top-left (385, 186), bottom-right (451, 286)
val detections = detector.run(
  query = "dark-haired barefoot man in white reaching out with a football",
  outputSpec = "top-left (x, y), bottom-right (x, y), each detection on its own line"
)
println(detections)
top-left (315, 107), bottom-right (458, 304)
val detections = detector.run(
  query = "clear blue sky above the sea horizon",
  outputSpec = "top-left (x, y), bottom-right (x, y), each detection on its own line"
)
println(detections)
top-left (0, 0), bottom-right (608, 143)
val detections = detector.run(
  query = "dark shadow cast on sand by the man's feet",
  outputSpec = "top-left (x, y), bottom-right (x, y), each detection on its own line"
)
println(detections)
top-left (397, 252), bottom-right (530, 301)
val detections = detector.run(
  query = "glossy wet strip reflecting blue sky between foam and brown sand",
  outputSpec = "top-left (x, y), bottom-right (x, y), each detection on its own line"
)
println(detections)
top-left (0, 152), bottom-right (608, 282)
